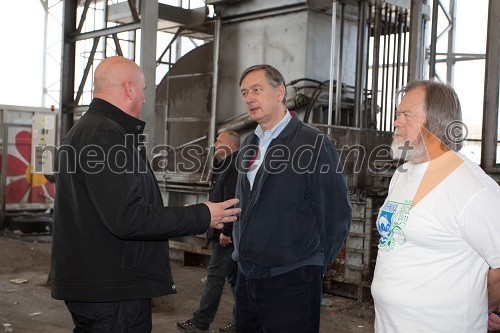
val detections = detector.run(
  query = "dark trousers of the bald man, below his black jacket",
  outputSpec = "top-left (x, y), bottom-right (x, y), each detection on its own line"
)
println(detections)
top-left (66, 299), bottom-right (152, 333)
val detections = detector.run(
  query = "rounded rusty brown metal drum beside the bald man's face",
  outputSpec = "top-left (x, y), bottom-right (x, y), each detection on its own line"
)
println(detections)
top-left (152, 43), bottom-right (213, 184)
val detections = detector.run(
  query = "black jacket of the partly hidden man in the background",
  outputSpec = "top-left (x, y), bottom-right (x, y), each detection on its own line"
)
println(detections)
top-left (207, 152), bottom-right (238, 242)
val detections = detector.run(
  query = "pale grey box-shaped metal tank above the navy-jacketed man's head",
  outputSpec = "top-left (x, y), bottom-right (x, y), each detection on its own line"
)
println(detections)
top-left (217, 0), bottom-right (356, 119)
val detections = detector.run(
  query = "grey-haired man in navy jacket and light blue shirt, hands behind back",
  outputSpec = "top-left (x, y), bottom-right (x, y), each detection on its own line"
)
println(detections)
top-left (233, 65), bottom-right (351, 333)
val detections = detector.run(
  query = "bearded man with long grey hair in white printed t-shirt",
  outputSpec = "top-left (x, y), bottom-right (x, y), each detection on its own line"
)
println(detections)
top-left (372, 81), bottom-right (500, 333)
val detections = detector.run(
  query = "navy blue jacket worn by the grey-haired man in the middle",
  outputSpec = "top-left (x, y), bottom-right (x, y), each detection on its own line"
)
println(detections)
top-left (233, 114), bottom-right (351, 279)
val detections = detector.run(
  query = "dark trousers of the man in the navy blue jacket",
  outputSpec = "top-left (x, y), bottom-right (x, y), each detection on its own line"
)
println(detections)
top-left (235, 266), bottom-right (323, 333)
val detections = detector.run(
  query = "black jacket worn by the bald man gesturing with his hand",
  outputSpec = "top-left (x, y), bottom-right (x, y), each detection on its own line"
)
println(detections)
top-left (51, 99), bottom-right (210, 302)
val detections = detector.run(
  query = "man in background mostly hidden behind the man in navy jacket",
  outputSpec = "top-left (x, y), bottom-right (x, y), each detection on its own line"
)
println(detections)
top-left (177, 131), bottom-right (240, 333)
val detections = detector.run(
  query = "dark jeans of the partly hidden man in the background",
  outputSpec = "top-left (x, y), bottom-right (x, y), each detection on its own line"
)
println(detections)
top-left (191, 242), bottom-right (238, 329)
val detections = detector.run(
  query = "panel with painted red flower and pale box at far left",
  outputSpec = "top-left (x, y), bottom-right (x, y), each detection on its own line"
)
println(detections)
top-left (0, 105), bottom-right (58, 233)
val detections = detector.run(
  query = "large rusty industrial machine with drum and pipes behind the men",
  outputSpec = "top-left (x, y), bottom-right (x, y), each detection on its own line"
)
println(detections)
top-left (152, 0), bottom-right (420, 299)
